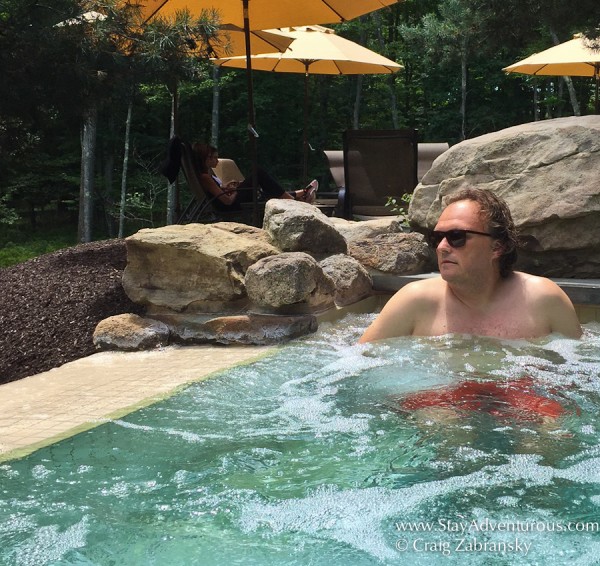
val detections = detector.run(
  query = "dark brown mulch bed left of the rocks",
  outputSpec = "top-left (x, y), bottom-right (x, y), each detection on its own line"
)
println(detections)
top-left (0, 240), bottom-right (142, 383)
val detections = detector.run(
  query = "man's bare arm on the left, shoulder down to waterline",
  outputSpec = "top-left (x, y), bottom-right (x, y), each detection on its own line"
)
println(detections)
top-left (358, 281), bottom-right (432, 344)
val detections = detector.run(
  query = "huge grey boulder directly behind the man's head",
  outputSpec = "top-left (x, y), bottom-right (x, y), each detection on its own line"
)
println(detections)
top-left (409, 116), bottom-right (600, 277)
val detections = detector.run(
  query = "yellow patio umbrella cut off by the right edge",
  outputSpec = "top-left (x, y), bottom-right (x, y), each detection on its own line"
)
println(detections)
top-left (503, 34), bottom-right (600, 113)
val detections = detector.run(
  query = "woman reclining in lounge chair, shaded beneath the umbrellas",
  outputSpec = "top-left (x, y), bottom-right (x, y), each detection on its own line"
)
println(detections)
top-left (192, 143), bottom-right (319, 210)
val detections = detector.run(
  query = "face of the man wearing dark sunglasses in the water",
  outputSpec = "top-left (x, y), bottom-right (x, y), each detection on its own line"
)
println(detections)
top-left (435, 200), bottom-right (500, 282)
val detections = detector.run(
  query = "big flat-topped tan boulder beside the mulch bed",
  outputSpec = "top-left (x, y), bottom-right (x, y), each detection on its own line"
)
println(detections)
top-left (123, 224), bottom-right (279, 312)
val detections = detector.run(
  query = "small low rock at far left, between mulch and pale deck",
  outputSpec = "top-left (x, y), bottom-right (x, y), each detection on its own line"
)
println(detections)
top-left (93, 313), bottom-right (170, 351)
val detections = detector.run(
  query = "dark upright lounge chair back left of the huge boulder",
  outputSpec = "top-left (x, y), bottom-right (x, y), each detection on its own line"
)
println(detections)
top-left (343, 129), bottom-right (417, 219)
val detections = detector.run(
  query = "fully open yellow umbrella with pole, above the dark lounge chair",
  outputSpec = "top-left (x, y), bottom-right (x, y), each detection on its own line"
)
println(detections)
top-left (212, 25), bottom-right (404, 182)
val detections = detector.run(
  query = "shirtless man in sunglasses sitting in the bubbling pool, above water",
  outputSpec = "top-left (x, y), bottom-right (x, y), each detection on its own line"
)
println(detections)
top-left (359, 189), bottom-right (581, 342)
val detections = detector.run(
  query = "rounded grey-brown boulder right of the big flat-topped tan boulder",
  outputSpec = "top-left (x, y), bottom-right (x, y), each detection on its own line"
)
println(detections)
top-left (246, 252), bottom-right (335, 313)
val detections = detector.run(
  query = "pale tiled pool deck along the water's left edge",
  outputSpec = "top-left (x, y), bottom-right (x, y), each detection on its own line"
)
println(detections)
top-left (0, 345), bottom-right (275, 462)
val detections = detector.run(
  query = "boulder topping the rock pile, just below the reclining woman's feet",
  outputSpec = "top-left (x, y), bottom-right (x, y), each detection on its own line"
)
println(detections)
top-left (263, 199), bottom-right (347, 255)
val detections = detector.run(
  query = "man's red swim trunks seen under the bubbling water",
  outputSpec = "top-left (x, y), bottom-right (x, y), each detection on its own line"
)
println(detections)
top-left (399, 377), bottom-right (567, 420)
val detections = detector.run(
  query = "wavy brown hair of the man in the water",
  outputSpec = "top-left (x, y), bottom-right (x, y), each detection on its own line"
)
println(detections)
top-left (444, 188), bottom-right (519, 277)
